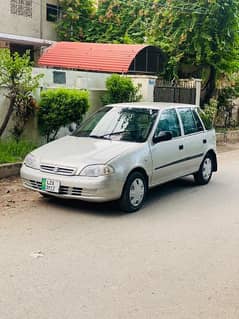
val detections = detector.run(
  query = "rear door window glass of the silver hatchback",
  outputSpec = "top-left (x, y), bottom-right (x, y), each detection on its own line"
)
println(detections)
top-left (179, 108), bottom-right (203, 135)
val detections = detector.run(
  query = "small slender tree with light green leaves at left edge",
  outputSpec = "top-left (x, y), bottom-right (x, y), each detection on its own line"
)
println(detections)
top-left (0, 49), bottom-right (42, 137)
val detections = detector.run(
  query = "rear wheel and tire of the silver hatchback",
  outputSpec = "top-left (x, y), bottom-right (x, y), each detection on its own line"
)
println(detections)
top-left (194, 154), bottom-right (213, 185)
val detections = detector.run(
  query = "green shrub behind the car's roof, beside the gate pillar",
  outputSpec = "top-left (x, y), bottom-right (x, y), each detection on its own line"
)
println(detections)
top-left (102, 74), bottom-right (141, 105)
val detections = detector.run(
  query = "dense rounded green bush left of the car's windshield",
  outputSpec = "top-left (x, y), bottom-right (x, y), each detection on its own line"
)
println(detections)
top-left (38, 89), bottom-right (89, 141)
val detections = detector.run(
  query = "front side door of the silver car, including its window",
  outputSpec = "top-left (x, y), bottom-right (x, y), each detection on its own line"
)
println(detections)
top-left (151, 108), bottom-right (185, 185)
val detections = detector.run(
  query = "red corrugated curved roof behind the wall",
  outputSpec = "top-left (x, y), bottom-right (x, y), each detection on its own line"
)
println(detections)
top-left (38, 42), bottom-right (147, 73)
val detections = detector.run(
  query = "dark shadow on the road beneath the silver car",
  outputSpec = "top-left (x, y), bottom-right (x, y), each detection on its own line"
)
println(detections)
top-left (41, 177), bottom-right (195, 217)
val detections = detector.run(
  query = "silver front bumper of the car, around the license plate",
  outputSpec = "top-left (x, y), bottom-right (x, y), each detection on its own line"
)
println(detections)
top-left (20, 164), bottom-right (123, 202)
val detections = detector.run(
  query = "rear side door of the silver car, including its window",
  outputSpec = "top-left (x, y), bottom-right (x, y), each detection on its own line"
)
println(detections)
top-left (177, 107), bottom-right (207, 175)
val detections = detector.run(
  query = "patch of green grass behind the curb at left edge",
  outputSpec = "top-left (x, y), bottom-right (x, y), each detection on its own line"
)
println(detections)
top-left (0, 140), bottom-right (37, 164)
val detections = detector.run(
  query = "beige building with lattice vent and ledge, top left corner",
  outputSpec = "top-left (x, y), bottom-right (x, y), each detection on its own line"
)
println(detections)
top-left (0, 0), bottom-right (60, 61)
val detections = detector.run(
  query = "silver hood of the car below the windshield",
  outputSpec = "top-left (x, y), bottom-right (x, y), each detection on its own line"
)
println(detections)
top-left (32, 136), bottom-right (140, 168)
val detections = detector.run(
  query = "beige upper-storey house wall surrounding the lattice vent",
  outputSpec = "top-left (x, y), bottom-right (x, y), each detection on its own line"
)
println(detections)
top-left (0, 0), bottom-right (57, 40)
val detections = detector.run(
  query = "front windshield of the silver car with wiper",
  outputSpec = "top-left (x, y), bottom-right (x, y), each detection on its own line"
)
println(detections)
top-left (73, 107), bottom-right (158, 143)
